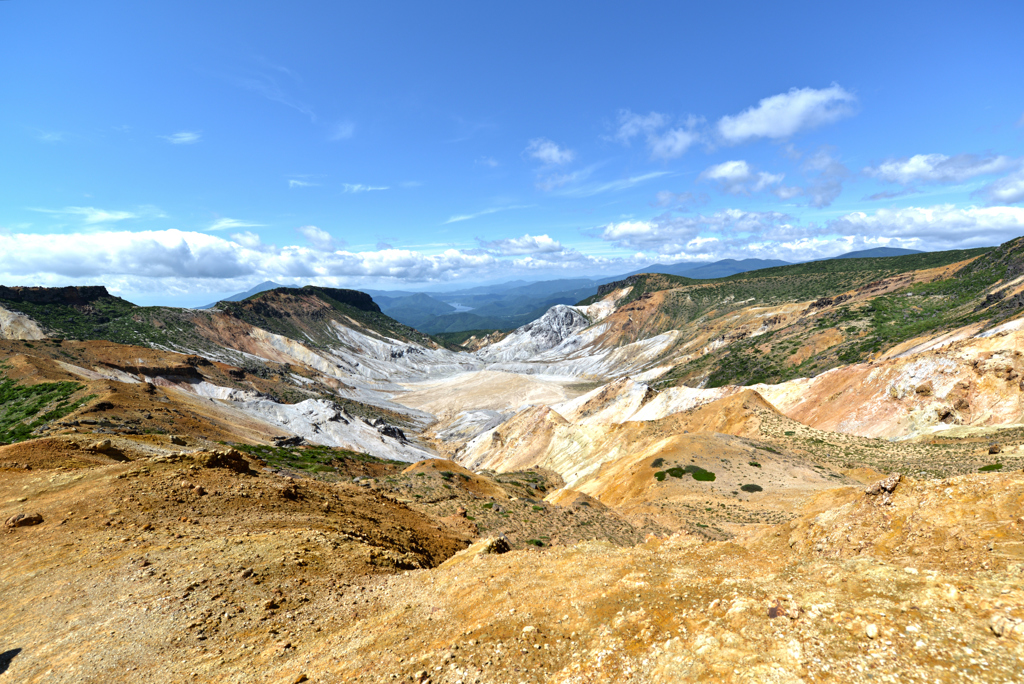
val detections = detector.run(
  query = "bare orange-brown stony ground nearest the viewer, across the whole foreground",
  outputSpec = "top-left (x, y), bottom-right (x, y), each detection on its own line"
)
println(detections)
top-left (0, 447), bottom-right (1024, 683)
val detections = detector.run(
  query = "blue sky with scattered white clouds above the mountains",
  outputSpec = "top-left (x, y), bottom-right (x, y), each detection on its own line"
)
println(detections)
top-left (0, 0), bottom-right (1024, 305)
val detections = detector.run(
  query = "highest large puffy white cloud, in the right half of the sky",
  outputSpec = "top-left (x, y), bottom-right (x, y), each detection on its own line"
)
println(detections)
top-left (718, 83), bottom-right (857, 143)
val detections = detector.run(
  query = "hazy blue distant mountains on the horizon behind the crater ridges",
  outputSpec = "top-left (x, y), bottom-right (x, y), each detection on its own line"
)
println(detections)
top-left (199, 247), bottom-right (919, 334)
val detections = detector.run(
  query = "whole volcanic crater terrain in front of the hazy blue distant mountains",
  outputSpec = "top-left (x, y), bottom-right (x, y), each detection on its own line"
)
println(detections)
top-left (6, 241), bottom-right (1024, 684)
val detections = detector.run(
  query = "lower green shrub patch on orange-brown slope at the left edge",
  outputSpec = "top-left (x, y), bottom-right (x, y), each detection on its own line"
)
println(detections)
top-left (0, 379), bottom-right (95, 442)
